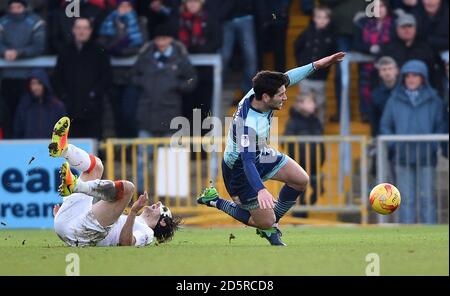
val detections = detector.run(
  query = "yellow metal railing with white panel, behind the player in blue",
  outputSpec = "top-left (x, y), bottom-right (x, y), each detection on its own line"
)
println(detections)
top-left (101, 136), bottom-right (368, 224)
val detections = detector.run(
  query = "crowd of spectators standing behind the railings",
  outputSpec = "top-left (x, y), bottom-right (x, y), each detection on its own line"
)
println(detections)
top-left (0, 0), bottom-right (449, 223)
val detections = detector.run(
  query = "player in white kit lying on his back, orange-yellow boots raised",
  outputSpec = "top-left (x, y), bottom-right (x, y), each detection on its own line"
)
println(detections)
top-left (49, 117), bottom-right (181, 246)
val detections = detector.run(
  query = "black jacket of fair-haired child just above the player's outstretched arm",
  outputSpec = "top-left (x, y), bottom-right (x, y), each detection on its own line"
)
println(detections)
top-left (294, 23), bottom-right (336, 80)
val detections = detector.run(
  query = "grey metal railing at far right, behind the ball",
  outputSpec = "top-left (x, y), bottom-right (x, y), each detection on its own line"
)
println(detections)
top-left (376, 134), bottom-right (449, 224)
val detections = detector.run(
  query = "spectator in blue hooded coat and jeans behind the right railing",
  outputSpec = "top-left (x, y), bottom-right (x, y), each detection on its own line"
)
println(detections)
top-left (380, 60), bottom-right (445, 224)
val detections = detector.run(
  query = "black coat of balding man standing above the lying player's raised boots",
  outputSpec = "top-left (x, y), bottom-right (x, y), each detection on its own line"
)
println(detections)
top-left (54, 42), bottom-right (112, 120)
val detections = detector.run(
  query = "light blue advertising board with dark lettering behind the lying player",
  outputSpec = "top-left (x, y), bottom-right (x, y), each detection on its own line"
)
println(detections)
top-left (0, 139), bottom-right (96, 230)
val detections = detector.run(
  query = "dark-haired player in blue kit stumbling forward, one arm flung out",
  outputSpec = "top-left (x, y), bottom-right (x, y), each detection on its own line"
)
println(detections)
top-left (197, 52), bottom-right (345, 246)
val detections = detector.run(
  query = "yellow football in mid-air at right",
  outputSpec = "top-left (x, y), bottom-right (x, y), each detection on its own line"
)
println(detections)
top-left (370, 183), bottom-right (401, 215)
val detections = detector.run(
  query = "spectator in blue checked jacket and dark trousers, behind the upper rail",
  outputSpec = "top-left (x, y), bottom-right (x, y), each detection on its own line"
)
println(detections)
top-left (99, 0), bottom-right (144, 138)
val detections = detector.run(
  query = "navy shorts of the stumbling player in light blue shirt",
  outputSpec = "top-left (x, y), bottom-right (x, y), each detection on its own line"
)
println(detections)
top-left (222, 153), bottom-right (288, 210)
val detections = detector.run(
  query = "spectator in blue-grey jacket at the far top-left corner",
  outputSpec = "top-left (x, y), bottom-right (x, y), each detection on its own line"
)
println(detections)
top-left (0, 0), bottom-right (45, 139)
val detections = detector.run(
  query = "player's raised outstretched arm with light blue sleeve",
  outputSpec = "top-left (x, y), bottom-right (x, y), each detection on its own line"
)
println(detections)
top-left (285, 52), bottom-right (345, 86)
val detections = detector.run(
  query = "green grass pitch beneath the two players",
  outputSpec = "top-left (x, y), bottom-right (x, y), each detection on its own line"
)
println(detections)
top-left (0, 225), bottom-right (449, 276)
